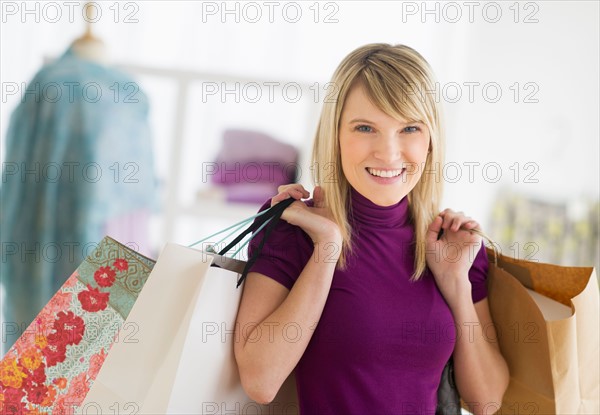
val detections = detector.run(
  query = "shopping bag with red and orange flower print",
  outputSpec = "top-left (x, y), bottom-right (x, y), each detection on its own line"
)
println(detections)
top-left (0, 237), bottom-right (154, 415)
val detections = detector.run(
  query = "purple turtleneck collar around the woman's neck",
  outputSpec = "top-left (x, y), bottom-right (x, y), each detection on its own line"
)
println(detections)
top-left (350, 187), bottom-right (410, 228)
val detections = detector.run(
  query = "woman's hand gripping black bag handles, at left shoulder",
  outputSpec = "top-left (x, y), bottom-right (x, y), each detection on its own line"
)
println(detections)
top-left (271, 183), bottom-right (342, 244)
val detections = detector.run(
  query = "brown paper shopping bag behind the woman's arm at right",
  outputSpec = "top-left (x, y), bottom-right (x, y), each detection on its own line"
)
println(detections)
top-left (488, 249), bottom-right (600, 414)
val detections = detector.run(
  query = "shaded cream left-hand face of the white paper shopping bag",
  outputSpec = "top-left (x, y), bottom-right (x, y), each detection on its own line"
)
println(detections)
top-left (82, 244), bottom-right (212, 414)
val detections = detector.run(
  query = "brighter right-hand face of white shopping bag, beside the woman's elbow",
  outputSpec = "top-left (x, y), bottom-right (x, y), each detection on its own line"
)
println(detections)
top-left (167, 256), bottom-right (298, 415)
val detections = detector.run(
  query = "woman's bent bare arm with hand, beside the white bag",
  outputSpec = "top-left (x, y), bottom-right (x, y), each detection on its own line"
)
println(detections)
top-left (234, 185), bottom-right (341, 403)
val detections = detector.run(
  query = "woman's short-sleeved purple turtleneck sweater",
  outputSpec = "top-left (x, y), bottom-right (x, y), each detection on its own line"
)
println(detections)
top-left (250, 189), bottom-right (488, 415)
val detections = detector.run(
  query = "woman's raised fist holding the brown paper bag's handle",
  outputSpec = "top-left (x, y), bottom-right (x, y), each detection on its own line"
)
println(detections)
top-left (426, 209), bottom-right (482, 306)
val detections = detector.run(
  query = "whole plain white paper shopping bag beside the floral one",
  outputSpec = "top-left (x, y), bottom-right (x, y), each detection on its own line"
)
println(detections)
top-left (81, 244), bottom-right (298, 414)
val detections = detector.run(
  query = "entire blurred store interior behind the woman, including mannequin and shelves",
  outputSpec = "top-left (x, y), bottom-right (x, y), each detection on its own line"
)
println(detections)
top-left (0, 1), bottom-right (600, 352)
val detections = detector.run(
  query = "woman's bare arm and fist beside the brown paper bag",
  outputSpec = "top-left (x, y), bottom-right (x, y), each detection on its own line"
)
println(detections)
top-left (427, 210), bottom-right (509, 415)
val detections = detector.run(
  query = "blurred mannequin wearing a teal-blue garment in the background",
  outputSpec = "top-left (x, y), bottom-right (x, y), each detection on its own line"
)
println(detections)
top-left (0, 1), bottom-right (158, 354)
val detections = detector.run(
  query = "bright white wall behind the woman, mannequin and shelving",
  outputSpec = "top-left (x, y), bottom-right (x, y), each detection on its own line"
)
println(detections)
top-left (0, 1), bottom-right (599, 247)
